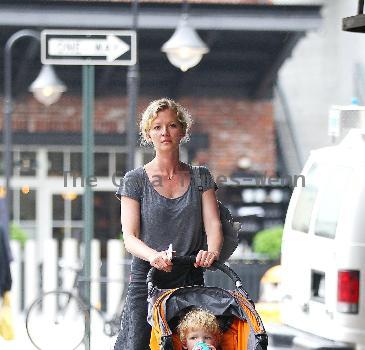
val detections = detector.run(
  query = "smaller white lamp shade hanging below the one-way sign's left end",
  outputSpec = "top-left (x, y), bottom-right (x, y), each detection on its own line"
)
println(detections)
top-left (29, 65), bottom-right (67, 106)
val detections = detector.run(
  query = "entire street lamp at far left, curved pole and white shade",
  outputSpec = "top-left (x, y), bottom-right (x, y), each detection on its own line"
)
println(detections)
top-left (3, 29), bottom-right (66, 238)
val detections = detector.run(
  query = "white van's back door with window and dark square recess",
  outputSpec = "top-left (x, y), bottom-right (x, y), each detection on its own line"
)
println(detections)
top-left (308, 164), bottom-right (353, 337)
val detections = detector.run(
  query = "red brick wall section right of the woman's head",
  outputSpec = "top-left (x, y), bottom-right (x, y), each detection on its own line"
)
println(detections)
top-left (181, 98), bottom-right (276, 176)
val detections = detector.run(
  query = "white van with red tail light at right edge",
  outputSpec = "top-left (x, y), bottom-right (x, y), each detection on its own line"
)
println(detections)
top-left (282, 129), bottom-right (365, 350)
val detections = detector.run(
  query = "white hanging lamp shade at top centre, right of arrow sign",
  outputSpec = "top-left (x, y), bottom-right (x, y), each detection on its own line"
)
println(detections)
top-left (161, 16), bottom-right (209, 72)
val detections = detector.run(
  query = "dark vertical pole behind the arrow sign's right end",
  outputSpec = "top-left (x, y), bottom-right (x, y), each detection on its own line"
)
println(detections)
top-left (127, 0), bottom-right (139, 170)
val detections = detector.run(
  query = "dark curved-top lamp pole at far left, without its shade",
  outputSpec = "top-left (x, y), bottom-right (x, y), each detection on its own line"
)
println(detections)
top-left (3, 29), bottom-right (40, 241)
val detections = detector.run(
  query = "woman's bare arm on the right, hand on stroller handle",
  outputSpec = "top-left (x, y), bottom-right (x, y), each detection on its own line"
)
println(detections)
top-left (195, 189), bottom-right (223, 267)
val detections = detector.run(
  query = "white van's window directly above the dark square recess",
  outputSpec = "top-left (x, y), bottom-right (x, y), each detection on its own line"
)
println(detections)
top-left (314, 166), bottom-right (351, 238)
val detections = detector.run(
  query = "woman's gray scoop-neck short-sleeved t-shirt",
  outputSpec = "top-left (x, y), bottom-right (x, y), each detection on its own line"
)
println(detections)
top-left (116, 166), bottom-right (216, 256)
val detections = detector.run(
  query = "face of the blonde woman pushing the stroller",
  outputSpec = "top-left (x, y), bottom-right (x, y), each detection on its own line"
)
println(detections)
top-left (148, 109), bottom-right (185, 150)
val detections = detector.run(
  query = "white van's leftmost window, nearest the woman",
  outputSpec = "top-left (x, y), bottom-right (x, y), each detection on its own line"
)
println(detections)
top-left (292, 163), bottom-right (319, 233)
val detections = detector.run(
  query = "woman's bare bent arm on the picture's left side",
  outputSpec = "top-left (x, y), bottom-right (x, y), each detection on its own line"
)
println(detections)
top-left (120, 196), bottom-right (172, 271)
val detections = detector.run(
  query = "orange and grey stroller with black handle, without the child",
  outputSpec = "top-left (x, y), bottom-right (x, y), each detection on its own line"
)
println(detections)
top-left (147, 256), bottom-right (268, 350)
